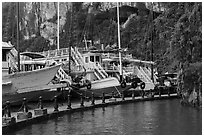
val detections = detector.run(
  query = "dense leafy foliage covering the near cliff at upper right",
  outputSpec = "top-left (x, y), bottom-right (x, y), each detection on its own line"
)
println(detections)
top-left (155, 2), bottom-right (202, 74)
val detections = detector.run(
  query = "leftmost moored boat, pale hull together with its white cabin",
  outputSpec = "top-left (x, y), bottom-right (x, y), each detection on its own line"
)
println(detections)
top-left (2, 42), bottom-right (67, 104)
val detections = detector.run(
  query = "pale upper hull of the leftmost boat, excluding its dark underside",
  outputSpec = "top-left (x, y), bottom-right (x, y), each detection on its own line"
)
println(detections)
top-left (2, 65), bottom-right (60, 94)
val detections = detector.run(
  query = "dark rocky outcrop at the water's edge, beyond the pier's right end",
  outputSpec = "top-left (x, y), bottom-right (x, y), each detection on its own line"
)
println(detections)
top-left (178, 63), bottom-right (202, 107)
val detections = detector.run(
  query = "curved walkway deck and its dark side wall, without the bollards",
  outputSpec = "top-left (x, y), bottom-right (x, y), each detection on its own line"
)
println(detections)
top-left (2, 94), bottom-right (178, 134)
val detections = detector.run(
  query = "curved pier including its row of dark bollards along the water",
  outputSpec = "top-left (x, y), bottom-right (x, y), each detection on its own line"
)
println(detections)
top-left (2, 92), bottom-right (178, 134)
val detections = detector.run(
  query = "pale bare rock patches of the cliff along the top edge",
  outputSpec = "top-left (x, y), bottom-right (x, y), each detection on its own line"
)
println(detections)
top-left (2, 2), bottom-right (150, 44)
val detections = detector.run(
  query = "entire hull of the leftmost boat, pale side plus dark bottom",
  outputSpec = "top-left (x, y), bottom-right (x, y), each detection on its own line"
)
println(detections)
top-left (2, 65), bottom-right (60, 102)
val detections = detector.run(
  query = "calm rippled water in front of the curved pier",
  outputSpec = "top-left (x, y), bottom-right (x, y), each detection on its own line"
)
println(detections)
top-left (12, 99), bottom-right (202, 135)
